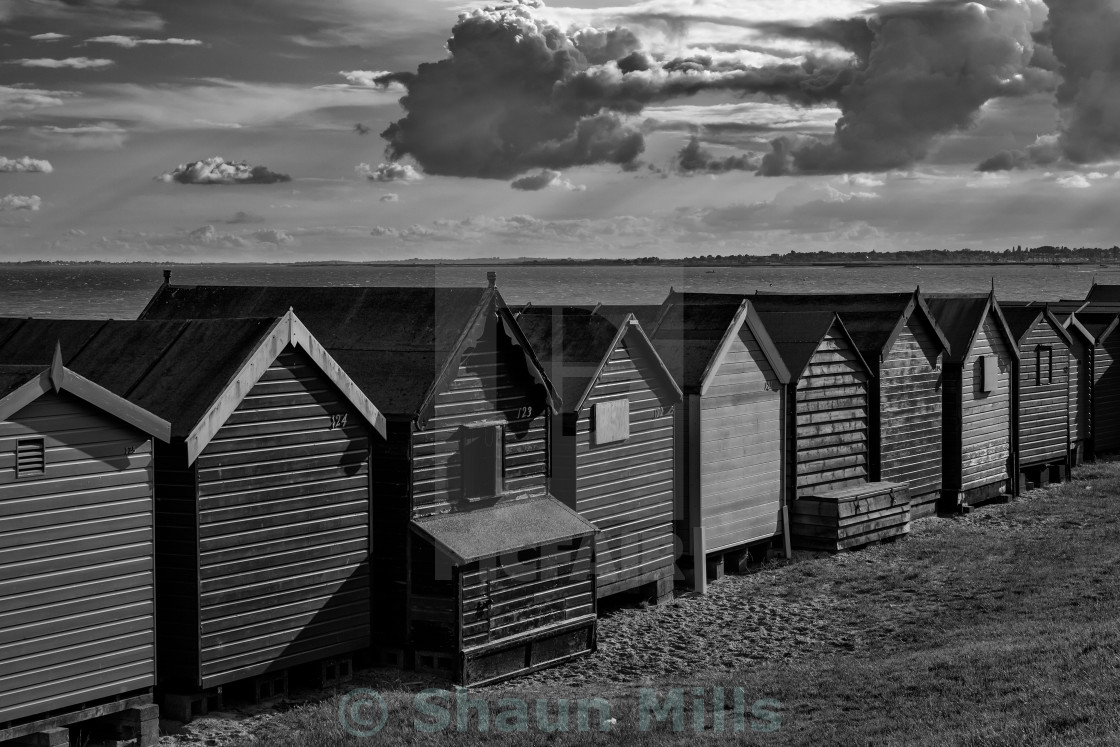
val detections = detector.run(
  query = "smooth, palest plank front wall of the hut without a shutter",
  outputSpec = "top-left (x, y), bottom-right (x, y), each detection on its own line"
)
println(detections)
top-left (699, 326), bottom-right (782, 552)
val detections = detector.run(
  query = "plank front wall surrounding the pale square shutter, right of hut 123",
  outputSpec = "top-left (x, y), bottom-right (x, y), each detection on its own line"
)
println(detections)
top-left (575, 340), bottom-right (676, 597)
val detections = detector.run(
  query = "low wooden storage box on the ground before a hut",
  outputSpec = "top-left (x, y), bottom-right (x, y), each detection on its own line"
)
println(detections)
top-left (790, 483), bottom-right (909, 552)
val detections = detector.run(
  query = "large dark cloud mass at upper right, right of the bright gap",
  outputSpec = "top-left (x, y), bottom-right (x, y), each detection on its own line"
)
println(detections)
top-left (762, 0), bottom-right (1054, 175)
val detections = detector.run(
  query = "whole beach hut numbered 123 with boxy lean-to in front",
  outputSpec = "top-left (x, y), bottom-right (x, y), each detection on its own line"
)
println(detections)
top-left (143, 274), bottom-right (596, 683)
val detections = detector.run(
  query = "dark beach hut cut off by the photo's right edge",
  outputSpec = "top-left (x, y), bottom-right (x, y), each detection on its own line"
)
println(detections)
top-left (1070, 307), bottom-right (1120, 457)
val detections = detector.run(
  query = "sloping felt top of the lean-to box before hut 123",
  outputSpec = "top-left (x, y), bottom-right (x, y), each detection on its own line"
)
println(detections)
top-left (412, 495), bottom-right (598, 566)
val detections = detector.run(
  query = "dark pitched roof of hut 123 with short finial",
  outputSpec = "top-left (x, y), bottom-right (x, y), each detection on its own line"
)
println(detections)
top-left (141, 282), bottom-right (558, 422)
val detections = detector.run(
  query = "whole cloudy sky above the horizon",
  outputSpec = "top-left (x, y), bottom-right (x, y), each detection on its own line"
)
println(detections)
top-left (0, 0), bottom-right (1120, 261)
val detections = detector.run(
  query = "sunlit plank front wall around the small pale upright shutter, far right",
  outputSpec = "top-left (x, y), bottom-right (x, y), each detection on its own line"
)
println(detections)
top-left (960, 315), bottom-right (1014, 491)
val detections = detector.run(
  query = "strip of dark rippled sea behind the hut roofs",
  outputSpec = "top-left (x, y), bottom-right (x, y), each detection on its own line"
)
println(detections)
top-left (0, 264), bottom-right (1120, 319)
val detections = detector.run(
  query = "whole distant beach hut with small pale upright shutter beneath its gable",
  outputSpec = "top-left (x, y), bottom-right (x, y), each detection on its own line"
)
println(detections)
top-left (926, 291), bottom-right (1019, 510)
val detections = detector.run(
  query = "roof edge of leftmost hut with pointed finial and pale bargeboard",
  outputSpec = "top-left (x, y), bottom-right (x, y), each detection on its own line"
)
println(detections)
top-left (0, 346), bottom-right (171, 442)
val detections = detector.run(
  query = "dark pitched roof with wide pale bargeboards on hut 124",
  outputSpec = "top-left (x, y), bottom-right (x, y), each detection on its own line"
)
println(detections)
top-left (0, 311), bottom-right (385, 463)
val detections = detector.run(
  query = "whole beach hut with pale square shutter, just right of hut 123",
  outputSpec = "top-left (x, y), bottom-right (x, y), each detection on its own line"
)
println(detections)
top-left (517, 306), bottom-right (681, 600)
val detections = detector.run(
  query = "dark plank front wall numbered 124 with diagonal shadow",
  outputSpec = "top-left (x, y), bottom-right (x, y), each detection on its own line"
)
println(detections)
top-left (190, 347), bottom-right (370, 688)
